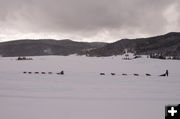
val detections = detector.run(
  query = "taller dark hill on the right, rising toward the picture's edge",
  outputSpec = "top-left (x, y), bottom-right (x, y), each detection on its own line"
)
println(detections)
top-left (86, 32), bottom-right (180, 57)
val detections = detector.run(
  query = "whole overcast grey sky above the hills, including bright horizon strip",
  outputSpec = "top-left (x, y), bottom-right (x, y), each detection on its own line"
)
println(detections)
top-left (0, 0), bottom-right (180, 42)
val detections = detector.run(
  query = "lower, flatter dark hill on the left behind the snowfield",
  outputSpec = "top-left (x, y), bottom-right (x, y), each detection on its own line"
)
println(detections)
top-left (0, 39), bottom-right (106, 57)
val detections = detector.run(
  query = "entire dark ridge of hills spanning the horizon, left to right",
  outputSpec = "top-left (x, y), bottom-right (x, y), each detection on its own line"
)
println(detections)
top-left (0, 32), bottom-right (180, 57)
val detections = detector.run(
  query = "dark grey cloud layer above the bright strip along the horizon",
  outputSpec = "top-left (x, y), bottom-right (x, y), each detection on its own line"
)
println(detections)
top-left (0, 0), bottom-right (179, 41)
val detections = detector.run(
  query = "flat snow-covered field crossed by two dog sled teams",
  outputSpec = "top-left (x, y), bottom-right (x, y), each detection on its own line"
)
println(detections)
top-left (0, 56), bottom-right (180, 119)
